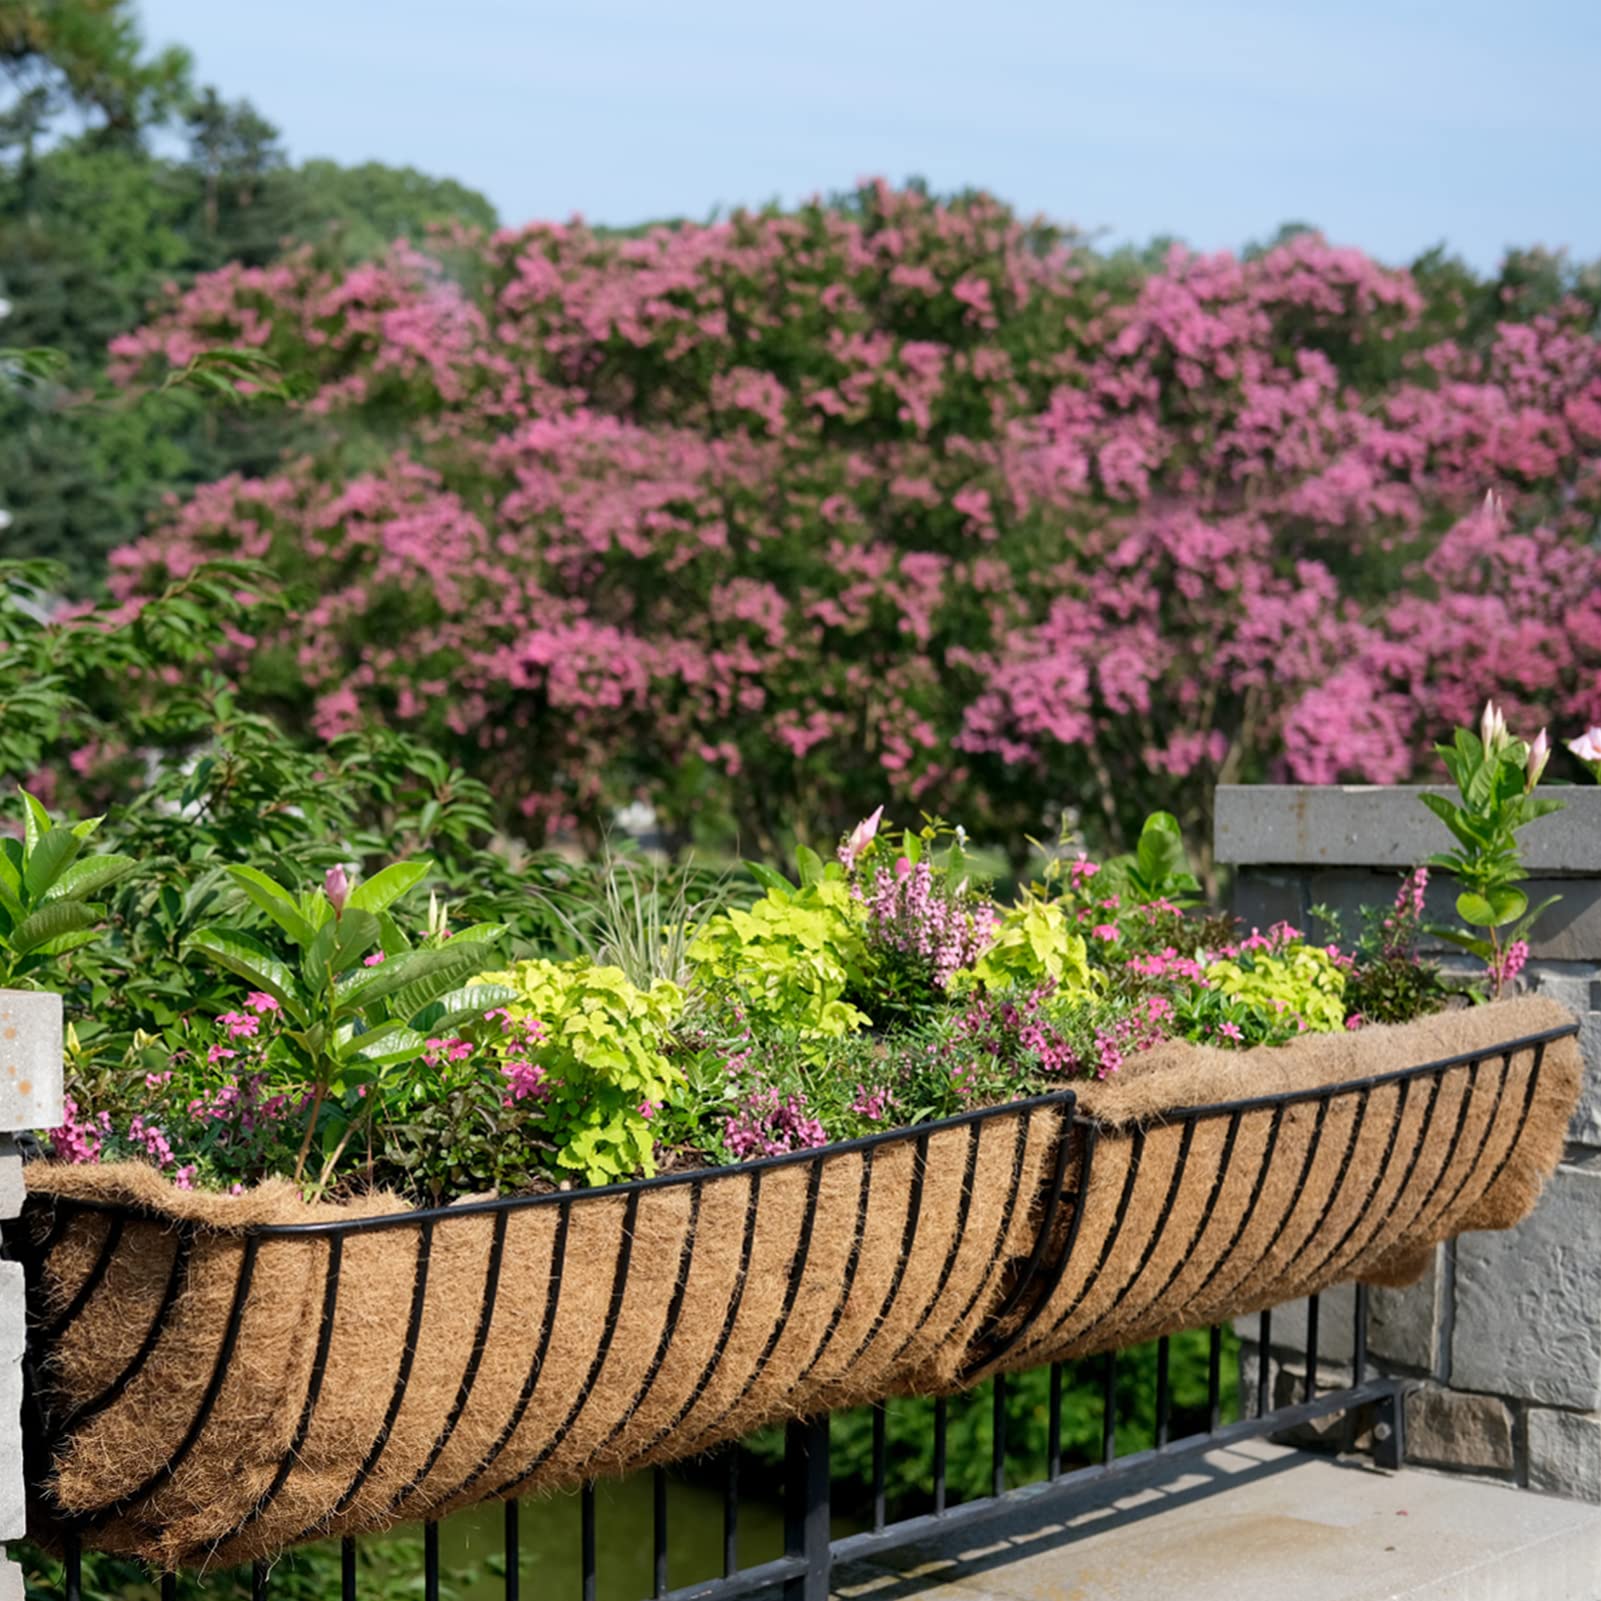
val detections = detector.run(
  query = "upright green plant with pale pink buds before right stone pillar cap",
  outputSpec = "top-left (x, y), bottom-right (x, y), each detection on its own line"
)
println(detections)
top-left (1422, 701), bottom-right (1563, 997)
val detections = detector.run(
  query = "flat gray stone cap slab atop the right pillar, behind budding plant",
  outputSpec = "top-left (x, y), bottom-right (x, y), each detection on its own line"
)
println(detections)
top-left (1212, 784), bottom-right (1601, 873)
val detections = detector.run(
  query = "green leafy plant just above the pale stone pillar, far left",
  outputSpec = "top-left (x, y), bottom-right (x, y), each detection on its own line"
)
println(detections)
top-left (0, 789), bottom-right (134, 988)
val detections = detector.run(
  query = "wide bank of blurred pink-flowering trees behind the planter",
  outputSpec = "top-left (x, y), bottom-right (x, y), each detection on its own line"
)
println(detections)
top-left (100, 184), bottom-right (1601, 851)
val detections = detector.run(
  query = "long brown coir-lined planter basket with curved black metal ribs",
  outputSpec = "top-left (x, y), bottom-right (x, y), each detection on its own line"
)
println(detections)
top-left (8, 999), bottom-right (1580, 1569)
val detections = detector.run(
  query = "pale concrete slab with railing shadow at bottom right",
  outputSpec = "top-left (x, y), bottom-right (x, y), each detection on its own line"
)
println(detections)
top-left (834, 1443), bottom-right (1601, 1601)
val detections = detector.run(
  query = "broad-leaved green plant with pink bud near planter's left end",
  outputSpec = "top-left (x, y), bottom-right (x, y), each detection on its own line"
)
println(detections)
top-left (187, 861), bottom-right (512, 1193)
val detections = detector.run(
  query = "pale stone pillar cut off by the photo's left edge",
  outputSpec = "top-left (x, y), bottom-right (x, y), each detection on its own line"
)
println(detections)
top-left (0, 989), bottom-right (62, 1601)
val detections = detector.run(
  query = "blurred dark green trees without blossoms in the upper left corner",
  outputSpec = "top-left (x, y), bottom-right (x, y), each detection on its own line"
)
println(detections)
top-left (0, 0), bottom-right (496, 591)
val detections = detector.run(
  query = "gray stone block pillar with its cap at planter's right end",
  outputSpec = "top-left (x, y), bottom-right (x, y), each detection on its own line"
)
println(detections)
top-left (1215, 784), bottom-right (1601, 1502)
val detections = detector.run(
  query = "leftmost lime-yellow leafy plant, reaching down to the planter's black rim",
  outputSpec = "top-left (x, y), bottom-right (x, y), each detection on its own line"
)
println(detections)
top-left (470, 961), bottom-right (684, 1185)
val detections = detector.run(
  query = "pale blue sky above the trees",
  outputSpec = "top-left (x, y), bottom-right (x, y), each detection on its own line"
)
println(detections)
top-left (141, 0), bottom-right (1601, 267)
